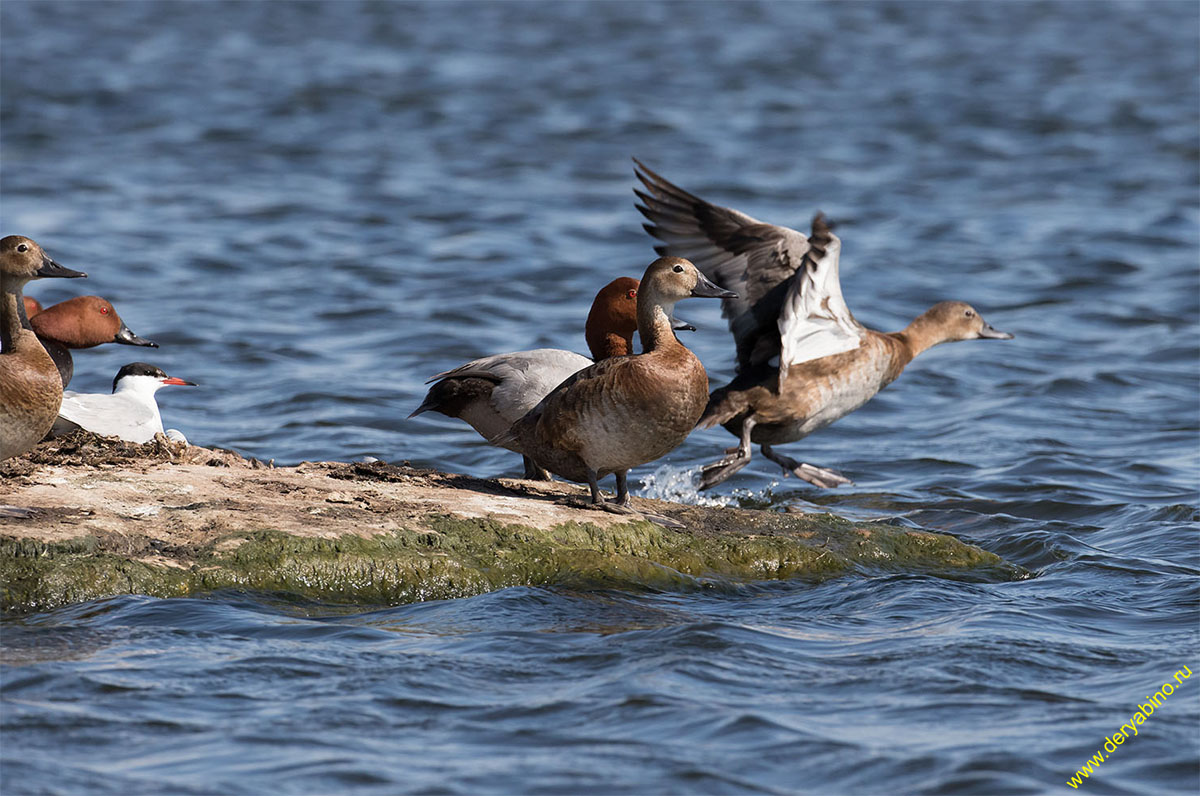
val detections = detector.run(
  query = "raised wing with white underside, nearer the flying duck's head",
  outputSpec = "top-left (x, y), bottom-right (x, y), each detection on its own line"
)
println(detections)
top-left (779, 213), bottom-right (866, 384)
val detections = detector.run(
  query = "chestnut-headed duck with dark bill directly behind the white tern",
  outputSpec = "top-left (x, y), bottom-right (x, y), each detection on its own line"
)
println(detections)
top-left (29, 295), bottom-right (158, 389)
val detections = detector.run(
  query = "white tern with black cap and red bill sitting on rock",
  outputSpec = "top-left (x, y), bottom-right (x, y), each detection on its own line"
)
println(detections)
top-left (54, 363), bottom-right (196, 443)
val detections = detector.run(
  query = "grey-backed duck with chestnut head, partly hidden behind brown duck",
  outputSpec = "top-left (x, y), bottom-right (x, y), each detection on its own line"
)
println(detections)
top-left (408, 276), bottom-right (695, 480)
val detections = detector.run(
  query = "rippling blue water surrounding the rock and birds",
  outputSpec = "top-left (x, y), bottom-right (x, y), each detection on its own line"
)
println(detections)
top-left (0, 0), bottom-right (1200, 795)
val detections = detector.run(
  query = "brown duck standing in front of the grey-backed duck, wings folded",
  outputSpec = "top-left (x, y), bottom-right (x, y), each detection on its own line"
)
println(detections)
top-left (492, 257), bottom-right (736, 514)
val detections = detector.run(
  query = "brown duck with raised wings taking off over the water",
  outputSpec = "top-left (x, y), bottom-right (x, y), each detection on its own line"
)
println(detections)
top-left (634, 158), bottom-right (1013, 490)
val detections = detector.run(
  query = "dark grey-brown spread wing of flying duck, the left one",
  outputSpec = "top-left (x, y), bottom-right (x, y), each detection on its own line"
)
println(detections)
top-left (634, 157), bottom-right (809, 373)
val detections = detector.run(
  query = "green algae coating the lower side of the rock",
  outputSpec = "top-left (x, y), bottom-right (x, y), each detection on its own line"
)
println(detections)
top-left (0, 509), bottom-right (1024, 612)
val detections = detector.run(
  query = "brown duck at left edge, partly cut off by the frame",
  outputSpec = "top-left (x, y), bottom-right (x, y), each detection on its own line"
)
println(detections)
top-left (0, 235), bottom-right (86, 460)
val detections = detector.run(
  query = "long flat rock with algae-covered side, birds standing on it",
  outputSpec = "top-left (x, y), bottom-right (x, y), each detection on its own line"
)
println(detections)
top-left (0, 435), bottom-right (1022, 611)
